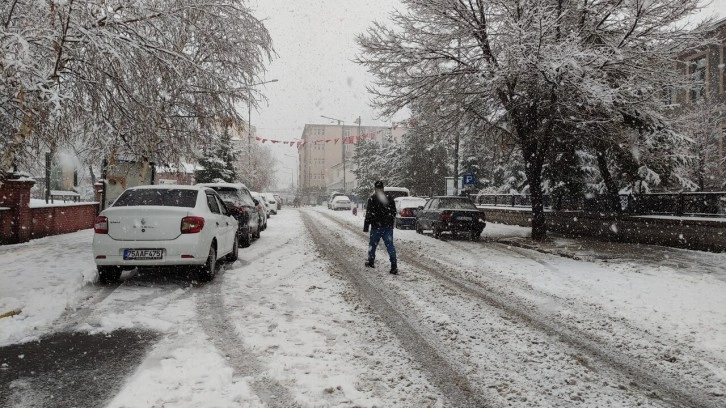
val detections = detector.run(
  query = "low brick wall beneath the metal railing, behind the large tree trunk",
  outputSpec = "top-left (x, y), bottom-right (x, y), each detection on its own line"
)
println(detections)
top-left (483, 208), bottom-right (726, 252)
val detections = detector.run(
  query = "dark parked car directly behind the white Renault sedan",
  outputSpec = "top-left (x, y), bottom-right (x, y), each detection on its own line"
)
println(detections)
top-left (199, 183), bottom-right (262, 248)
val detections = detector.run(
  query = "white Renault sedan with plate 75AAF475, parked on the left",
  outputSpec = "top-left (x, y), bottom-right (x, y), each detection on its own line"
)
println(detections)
top-left (93, 184), bottom-right (239, 283)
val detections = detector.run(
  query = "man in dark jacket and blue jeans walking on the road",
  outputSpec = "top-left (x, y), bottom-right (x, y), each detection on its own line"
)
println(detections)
top-left (363, 180), bottom-right (398, 275)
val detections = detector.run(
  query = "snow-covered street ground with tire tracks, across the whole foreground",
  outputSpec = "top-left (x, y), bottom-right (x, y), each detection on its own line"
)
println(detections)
top-left (0, 208), bottom-right (726, 407)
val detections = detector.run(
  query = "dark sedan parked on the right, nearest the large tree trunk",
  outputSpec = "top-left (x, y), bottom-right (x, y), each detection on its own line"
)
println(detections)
top-left (416, 196), bottom-right (486, 240)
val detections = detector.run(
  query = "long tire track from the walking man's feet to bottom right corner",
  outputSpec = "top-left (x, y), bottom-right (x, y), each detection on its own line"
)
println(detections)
top-left (318, 212), bottom-right (726, 408)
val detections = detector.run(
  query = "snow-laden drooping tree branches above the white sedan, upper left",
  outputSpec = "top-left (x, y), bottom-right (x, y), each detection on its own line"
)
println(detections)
top-left (0, 0), bottom-right (271, 182)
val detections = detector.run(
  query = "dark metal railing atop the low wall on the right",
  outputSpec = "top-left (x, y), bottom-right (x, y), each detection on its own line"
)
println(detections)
top-left (472, 192), bottom-right (726, 217)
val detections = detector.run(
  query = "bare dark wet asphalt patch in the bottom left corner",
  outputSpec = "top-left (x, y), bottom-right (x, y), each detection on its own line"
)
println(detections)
top-left (0, 329), bottom-right (158, 407)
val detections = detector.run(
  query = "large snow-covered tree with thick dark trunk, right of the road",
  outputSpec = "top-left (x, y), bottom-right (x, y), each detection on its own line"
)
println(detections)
top-left (358, 0), bottom-right (712, 239)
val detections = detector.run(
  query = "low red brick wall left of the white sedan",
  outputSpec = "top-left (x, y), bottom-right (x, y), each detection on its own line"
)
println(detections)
top-left (30, 203), bottom-right (98, 239)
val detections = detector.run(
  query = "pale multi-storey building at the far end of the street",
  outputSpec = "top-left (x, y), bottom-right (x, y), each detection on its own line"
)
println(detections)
top-left (298, 124), bottom-right (406, 203)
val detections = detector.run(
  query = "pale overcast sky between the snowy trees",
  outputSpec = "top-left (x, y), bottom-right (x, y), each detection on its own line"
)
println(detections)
top-left (248, 0), bottom-right (726, 187)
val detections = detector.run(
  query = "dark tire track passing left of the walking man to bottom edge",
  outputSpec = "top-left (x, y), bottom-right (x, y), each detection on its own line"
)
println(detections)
top-left (301, 212), bottom-right (491, 407)
